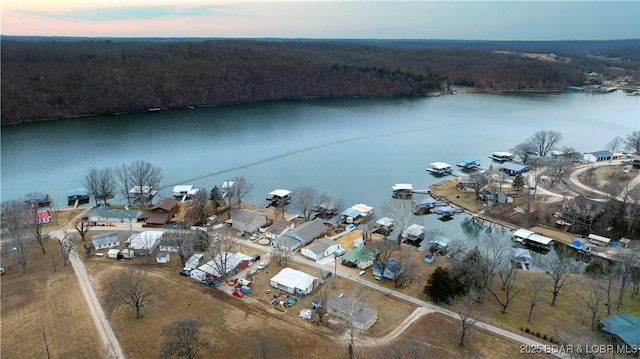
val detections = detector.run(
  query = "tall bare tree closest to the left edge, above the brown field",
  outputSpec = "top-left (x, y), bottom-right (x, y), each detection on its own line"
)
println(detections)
top-left (1, 200), bottom-right (33, 273)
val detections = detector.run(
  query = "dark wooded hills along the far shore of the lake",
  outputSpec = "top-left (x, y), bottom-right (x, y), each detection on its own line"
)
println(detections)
top-left (1, 36), bottom-right (640, 124)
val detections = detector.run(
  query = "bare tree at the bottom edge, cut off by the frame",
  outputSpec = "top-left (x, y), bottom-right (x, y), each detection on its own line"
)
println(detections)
top-left (160, 317), bottom-right (209, 359)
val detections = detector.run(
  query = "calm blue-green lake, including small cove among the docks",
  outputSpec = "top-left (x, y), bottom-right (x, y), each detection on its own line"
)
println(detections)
top-left (1, 91), bottom-right (640, 250)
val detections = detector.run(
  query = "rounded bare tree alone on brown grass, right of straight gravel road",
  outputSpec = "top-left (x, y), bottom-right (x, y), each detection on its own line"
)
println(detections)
top-left (105, 269), bottom-right (160, 319)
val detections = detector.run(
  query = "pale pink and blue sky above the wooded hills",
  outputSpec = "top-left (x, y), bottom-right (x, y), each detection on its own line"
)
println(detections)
top-left (2, 0), bottom-right (640, 40)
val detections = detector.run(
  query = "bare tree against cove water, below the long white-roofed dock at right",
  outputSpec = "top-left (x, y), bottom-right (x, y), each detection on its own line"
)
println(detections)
top-left (536, 247), bottom-right (578, 306)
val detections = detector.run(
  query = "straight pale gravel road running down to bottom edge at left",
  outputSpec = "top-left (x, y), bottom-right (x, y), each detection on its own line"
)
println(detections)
top-left (49, 230), bottom-right (125, 359)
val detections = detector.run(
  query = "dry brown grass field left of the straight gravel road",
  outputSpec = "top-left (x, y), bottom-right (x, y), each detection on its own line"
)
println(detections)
top-left (0, 240), bottom-right (105, 358)
